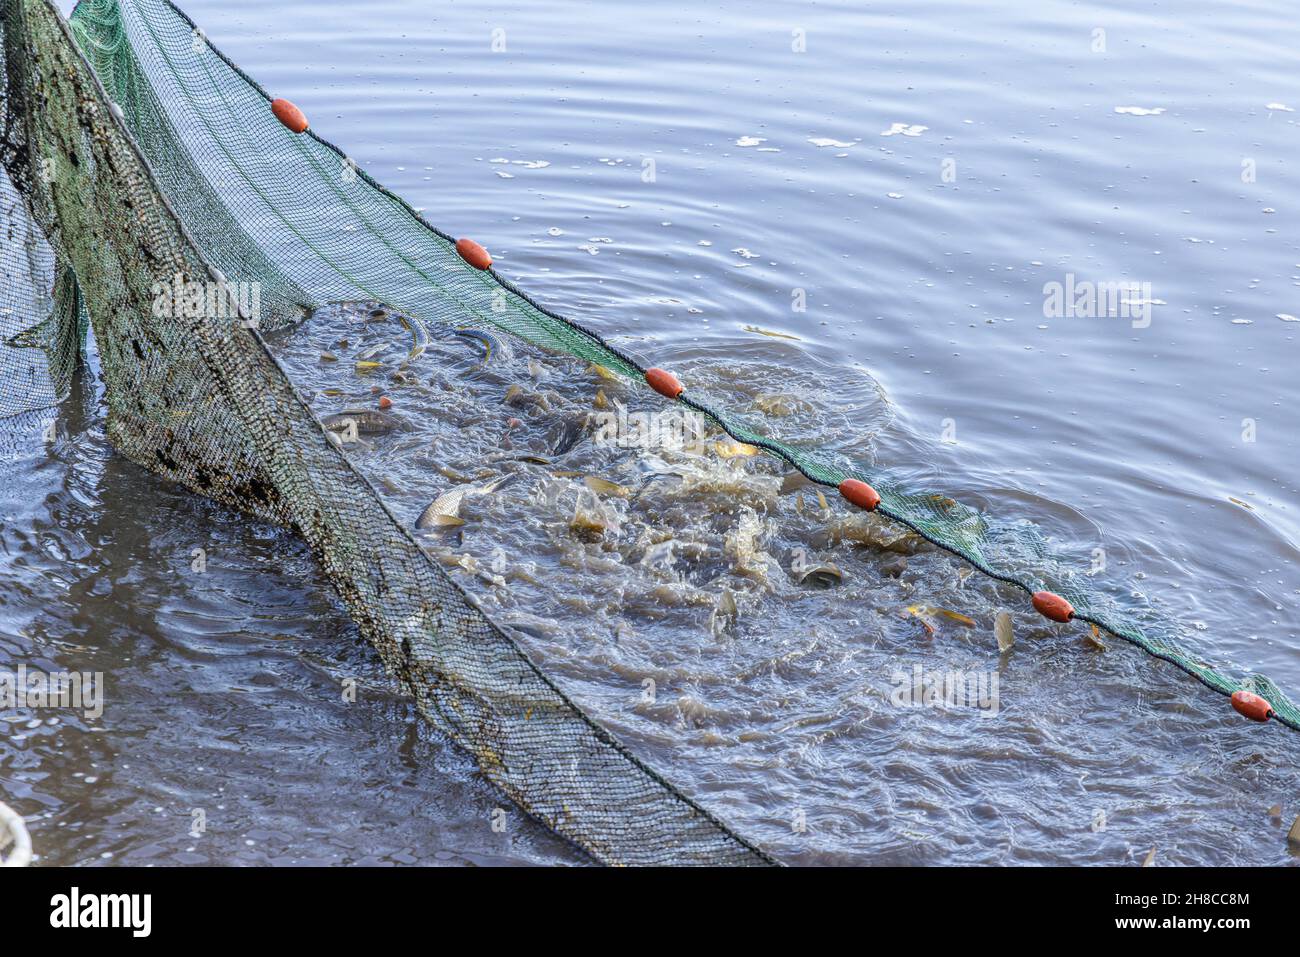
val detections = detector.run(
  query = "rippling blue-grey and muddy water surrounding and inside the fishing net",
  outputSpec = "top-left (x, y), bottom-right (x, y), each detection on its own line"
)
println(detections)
top-left (0, 0), bottom-right (1300, 865)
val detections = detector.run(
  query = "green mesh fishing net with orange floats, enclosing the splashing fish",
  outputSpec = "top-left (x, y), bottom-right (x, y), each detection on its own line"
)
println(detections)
top-left (0, 0), bottom-right (1300, 863)
